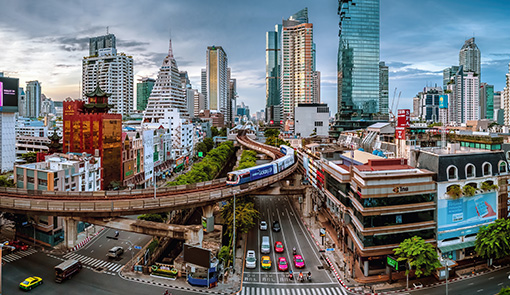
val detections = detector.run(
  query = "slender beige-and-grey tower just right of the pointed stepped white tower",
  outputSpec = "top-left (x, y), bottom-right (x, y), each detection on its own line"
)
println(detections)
top-left (202, 46), bottom-right (229, 122)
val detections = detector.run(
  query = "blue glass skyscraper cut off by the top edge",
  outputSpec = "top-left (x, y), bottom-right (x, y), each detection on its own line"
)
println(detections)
top-left (337, 0), bottom-right (380, 114)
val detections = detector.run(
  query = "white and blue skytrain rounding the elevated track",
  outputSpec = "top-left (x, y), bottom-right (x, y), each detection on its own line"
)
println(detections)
top-left (227, 145), bottom-right (294, 185)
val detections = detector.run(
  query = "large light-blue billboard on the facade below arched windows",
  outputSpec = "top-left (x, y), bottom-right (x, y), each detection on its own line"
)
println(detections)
top-left (437, 191), bottom-right (498, 240)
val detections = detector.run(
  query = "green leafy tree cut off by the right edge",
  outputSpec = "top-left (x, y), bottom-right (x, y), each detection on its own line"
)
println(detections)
top-left (475, 219), bottom-right (510, 259)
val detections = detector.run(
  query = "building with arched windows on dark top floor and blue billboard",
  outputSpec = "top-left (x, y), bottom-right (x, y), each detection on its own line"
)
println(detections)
top-left (410, 144), bottom-right (508, 260)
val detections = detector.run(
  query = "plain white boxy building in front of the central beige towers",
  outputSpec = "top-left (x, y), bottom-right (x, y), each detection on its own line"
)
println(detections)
top-left (294, 103), bottom-right (329, 137)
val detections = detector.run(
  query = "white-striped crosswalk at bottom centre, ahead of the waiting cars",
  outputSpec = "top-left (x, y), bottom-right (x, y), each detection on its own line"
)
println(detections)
top-left (240, 287), bottom-right (347, 295)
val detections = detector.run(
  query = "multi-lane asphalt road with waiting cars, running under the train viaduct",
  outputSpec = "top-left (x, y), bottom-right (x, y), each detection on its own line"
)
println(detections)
top-left (241, 196), bottom-right (347, 295)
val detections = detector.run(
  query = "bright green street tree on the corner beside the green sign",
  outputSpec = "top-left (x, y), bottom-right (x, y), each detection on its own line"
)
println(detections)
top-left (393, 236), bottom-right (441, 286)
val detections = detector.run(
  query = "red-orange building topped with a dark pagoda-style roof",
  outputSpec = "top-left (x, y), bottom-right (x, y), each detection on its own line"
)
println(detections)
top-left (62, 86), bottom-right (122, 189)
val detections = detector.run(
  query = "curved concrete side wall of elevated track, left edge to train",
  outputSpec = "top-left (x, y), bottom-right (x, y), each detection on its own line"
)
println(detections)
top-left (0, 163), bottom-right (297, 216)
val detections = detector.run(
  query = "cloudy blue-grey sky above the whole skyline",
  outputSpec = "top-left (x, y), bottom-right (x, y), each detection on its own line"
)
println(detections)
top-left (0, 0), bottom-right (510, 114)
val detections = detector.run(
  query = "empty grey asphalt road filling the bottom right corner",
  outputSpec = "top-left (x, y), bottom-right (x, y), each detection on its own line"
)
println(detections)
top-left (410, 268), bottom-right (510, 295)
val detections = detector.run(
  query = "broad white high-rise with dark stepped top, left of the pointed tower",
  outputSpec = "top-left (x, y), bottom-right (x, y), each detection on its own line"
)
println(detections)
top-left (82, 35), bottom-right (134, 116)
